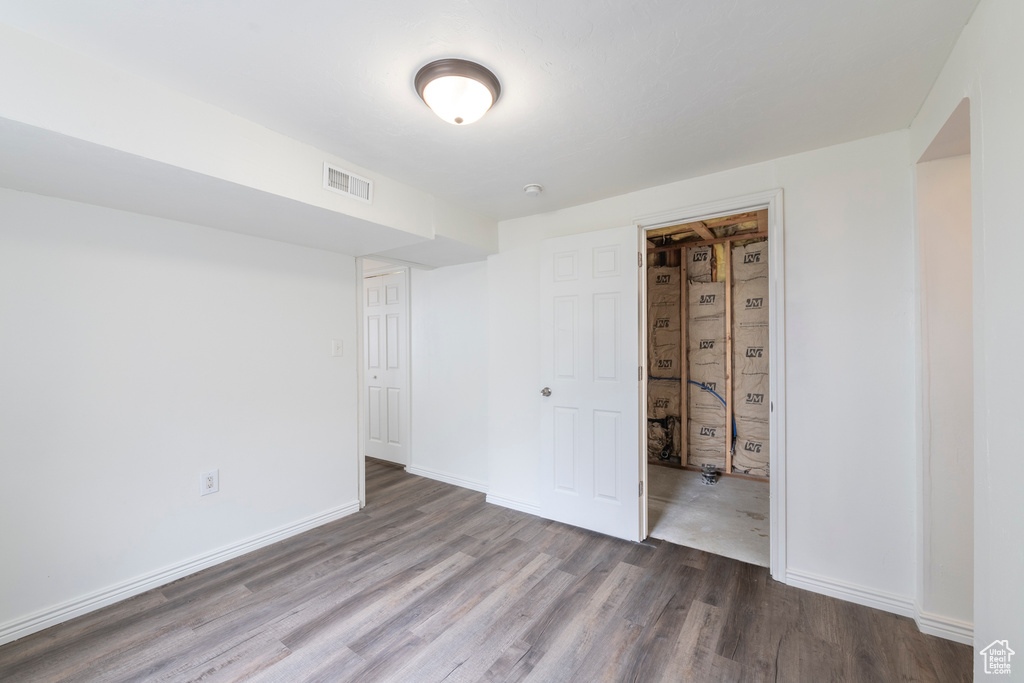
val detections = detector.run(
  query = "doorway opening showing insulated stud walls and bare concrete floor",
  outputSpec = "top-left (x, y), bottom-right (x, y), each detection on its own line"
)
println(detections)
top-left (641, 194), bottom-right (780, 574)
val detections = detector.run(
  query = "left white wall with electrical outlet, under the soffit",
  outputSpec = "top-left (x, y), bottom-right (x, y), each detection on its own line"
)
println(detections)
top-left (0, 189), bottom-right (357, 639)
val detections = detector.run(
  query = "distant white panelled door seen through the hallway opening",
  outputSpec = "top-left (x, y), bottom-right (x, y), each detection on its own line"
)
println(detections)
top-left (362, 271), bottom-right (409, 465)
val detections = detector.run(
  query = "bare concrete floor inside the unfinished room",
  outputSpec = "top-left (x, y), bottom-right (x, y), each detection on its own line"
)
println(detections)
top-left (647, 465), bottom-right (770, 567)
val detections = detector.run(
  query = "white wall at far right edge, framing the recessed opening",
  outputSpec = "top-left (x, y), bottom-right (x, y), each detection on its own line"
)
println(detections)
top-left (910, 0), bottom-right (1024, 663)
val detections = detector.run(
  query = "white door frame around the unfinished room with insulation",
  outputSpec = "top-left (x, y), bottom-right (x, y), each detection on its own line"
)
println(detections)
top-left (633, 187), bottom-right (786, 583)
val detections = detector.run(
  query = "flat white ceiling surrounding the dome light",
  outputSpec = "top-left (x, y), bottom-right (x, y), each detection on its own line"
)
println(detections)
top-left (0, 0), bottom-right (978, 219)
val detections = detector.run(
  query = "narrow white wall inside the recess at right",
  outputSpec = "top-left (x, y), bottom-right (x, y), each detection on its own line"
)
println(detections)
top-left (916, 156), bottom-right (974, 631)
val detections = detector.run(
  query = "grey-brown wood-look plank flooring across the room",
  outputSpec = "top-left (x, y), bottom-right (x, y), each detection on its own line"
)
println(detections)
top-left (0, 461), bottom-right (972, 683)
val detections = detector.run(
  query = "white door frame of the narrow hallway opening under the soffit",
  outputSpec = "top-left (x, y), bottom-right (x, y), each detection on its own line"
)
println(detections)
top-left (355, 256), bottom-right (413, 510)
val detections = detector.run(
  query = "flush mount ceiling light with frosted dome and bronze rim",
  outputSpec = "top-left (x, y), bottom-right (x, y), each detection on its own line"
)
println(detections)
top-left (416, 59), bottom-right (502, 126)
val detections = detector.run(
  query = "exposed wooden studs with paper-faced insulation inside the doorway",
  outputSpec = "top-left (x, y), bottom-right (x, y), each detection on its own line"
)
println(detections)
top-left (647, 210), bottom-right (771, 480)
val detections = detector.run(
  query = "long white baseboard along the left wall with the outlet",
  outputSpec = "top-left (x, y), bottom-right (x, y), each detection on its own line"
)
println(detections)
top-left (0, 501), bottom-right (359, 645)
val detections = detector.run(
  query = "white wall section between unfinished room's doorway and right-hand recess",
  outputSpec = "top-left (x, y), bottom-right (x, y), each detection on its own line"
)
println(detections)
top-left (779, 133), bottom-right (916, 610)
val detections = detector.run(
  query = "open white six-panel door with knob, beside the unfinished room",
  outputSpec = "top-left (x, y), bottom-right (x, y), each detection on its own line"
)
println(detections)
top-left (537, 226), bottom-right (641, 541)
